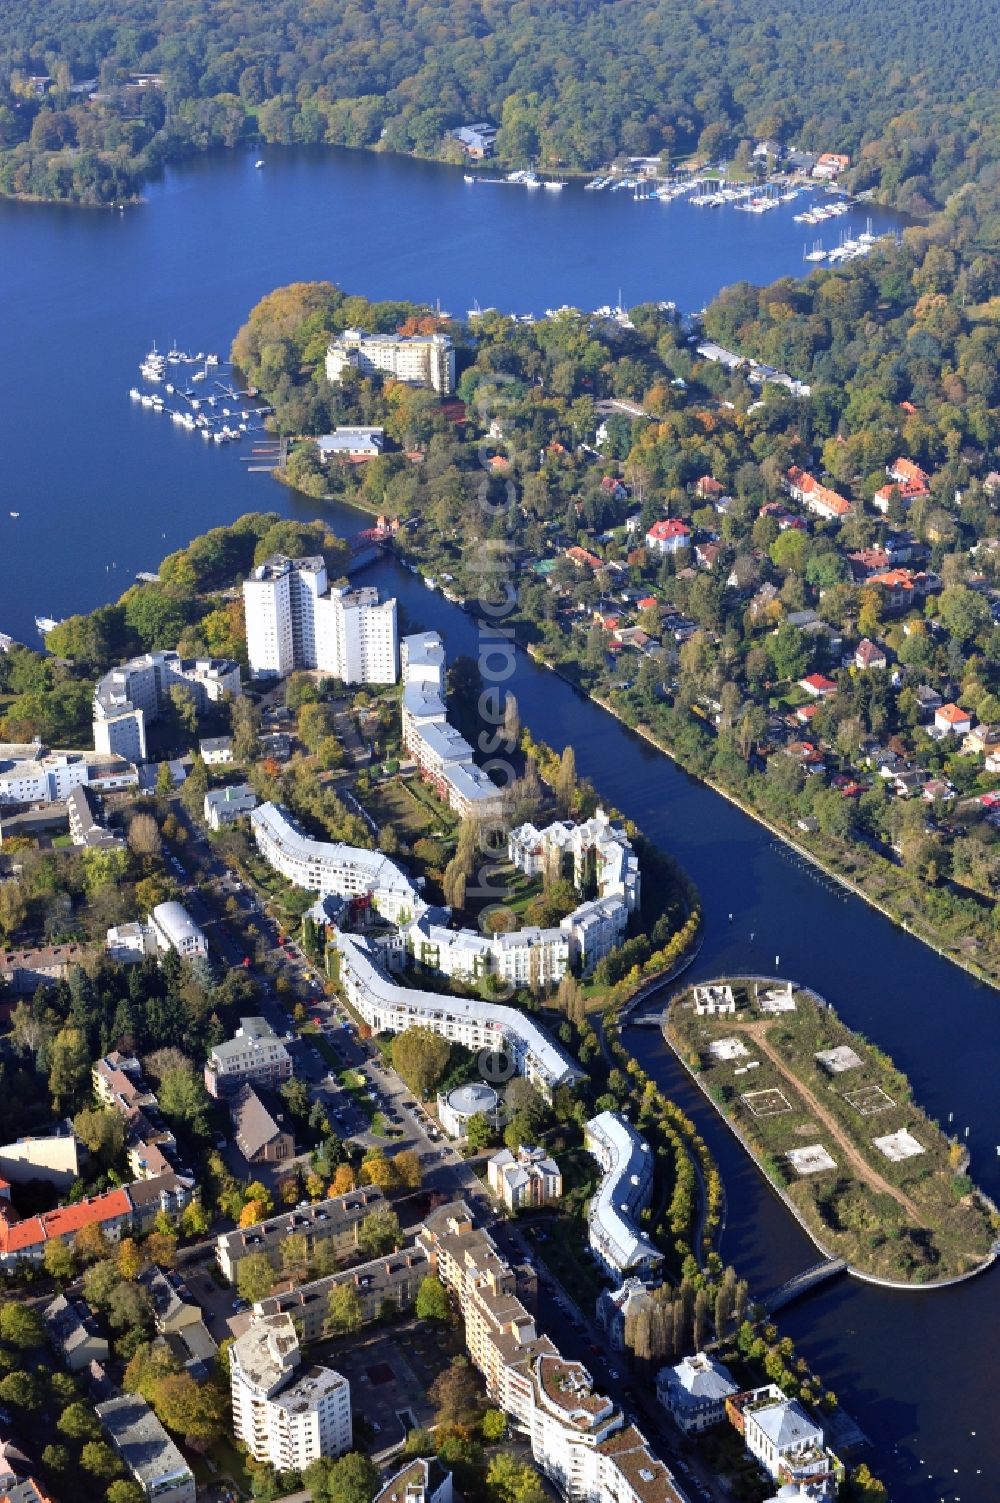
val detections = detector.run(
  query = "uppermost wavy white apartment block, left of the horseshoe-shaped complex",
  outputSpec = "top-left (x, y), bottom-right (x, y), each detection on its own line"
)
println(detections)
top-left (250, 804), bottom-right (427, 924)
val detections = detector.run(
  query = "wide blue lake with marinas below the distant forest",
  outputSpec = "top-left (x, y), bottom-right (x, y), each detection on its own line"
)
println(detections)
top-left (0, 147), bottom-right (895, 640)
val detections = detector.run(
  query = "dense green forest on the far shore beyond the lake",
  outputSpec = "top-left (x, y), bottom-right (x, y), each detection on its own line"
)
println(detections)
top-left (0, 0), bottom-right (1000, 213)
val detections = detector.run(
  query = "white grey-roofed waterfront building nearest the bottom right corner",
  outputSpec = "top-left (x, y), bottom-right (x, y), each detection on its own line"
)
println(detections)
top-left (726, 1383), bottom-right (844, 1498)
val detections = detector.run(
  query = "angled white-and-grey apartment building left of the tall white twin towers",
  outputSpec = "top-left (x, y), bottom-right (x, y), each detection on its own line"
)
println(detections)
top-left (93, 652), bottom-right (241, 762)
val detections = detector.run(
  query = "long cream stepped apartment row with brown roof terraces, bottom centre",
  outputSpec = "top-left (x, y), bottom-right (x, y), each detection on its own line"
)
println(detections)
top-left (418, 1202), bottom-right (684, 1503)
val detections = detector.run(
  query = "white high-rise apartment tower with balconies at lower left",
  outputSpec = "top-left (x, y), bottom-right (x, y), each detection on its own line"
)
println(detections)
top-left (229, 1315), bottom-right (352, 1471)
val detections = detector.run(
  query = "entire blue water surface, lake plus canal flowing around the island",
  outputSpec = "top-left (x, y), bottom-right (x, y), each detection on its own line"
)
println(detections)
top-left (0, 149), bottom-right (1000, 1503)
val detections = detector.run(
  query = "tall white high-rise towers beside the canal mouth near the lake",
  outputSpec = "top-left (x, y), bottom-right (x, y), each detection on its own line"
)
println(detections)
top-left (244, 553), bottom-right (398, 684)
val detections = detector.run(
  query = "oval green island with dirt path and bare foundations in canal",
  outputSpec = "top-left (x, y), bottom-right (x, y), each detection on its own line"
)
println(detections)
top-left (663, 977), bottom-right (998, 1287)
